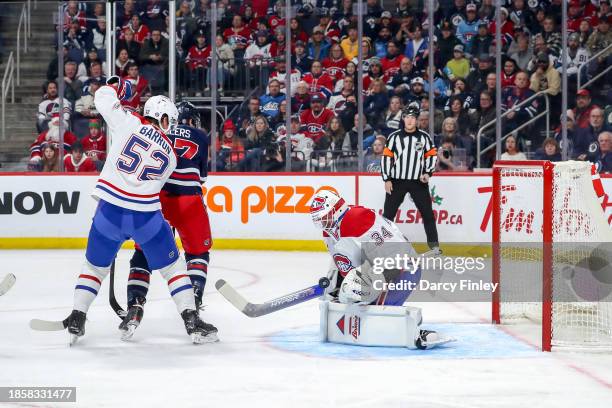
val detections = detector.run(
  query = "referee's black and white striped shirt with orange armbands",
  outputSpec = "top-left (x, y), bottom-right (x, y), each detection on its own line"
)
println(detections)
top-left (381, 128), bottom-right (438, 181)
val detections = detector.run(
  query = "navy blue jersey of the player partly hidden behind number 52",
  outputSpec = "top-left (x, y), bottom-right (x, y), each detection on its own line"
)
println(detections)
top-left (163, 125), bottom-right (209, 195)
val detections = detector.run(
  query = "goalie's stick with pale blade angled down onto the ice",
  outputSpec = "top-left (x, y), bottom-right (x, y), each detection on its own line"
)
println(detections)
top-left (215, 278), bottom-right (330, 317)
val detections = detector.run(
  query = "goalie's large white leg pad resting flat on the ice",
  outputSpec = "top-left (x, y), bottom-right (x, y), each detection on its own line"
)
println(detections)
top-left (319, 300), bottom-right (422, 349)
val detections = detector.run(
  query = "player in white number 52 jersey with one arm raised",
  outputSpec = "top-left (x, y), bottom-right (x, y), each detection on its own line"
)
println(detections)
top-left (68, 77), bottom-right (217, 343)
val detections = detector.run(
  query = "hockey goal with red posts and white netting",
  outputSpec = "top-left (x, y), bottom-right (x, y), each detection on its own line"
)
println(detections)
top-left (492, 161), bottom-right (612, 351)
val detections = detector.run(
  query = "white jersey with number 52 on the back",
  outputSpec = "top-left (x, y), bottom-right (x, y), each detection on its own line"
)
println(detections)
top-left (92, 86), bottom-right (177, 211)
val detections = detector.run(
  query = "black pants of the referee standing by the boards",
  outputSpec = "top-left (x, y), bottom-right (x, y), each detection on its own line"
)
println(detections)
top-left (383, 180), bottom-right (439, 248)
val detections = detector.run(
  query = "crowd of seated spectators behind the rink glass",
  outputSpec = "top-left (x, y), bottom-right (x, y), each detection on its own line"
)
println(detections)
top-left (26, 0), bottom-right (612, 172)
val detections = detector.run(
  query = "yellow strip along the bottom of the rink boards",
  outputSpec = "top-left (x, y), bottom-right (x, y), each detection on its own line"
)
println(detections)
top-left (0, 237), bottom-right (491, 257)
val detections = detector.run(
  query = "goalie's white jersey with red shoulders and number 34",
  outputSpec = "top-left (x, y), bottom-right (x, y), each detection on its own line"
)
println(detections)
top-left (323, 206), bottom-right (418, 277)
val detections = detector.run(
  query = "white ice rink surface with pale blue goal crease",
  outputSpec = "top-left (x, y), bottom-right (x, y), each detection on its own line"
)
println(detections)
top-left (0, 250), bottom-right (612, 408)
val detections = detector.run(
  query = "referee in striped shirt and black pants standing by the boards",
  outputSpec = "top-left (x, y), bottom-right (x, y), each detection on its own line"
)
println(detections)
top-left (381, 105), bottom-right (439, 250)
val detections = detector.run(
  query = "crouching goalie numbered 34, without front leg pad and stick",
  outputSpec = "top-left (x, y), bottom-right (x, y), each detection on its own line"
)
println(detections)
top-left (310, 189), bottom-right (452, 349)
